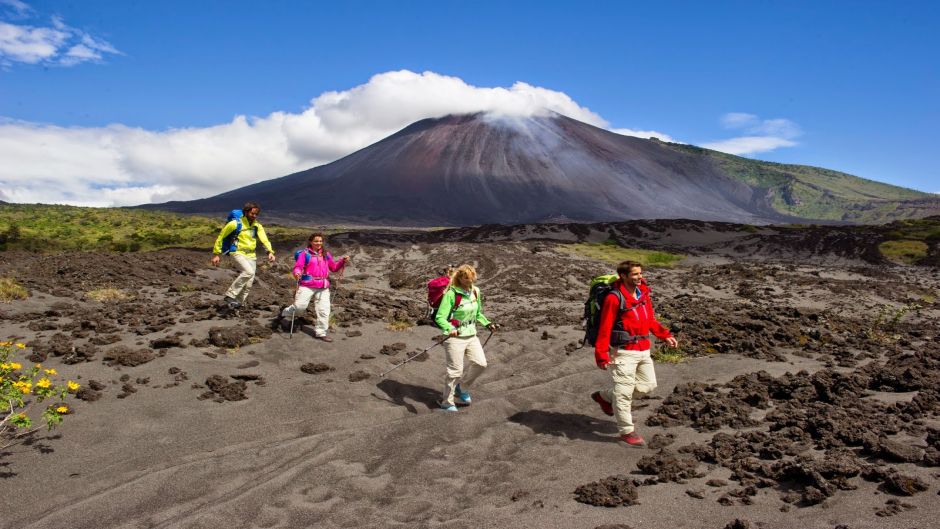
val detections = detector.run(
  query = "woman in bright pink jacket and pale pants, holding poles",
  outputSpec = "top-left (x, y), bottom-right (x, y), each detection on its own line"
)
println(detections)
top-left (280, 233), bottom-right (349, 342)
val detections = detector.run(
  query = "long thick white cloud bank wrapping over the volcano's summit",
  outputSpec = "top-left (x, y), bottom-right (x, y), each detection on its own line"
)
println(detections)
top-left (0, 71), bottom-right (624, 206)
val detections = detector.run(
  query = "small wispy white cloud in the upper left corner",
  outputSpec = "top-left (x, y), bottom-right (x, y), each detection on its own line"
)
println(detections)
top-left (0, 5), bottom-right (121, 68)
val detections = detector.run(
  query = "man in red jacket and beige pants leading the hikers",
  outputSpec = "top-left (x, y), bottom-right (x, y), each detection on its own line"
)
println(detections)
top-left (591, 261), bottom-right (679, 446)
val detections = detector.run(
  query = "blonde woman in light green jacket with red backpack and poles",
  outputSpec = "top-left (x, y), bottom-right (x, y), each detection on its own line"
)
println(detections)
top-left (434, 264), bottom-right (499, 411)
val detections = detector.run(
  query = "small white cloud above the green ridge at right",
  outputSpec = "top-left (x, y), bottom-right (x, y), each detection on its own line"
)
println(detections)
top-left (699, 112), bottom-right (803, 156)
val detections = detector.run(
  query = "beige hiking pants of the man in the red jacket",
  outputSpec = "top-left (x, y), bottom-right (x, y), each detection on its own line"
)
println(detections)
top-left (601, 349), bottom-right (656, 434)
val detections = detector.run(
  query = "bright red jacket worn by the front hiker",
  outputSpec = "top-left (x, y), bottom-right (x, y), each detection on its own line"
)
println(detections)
top-left (594, 279), bottom-right (672, 366)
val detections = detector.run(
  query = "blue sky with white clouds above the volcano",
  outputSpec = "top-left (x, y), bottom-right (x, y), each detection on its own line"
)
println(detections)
top-left (0, 0), bottom-right (940, 205)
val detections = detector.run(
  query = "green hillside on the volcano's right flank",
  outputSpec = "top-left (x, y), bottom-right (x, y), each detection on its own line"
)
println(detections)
top-left (666, 143), bottom-right (940, 223)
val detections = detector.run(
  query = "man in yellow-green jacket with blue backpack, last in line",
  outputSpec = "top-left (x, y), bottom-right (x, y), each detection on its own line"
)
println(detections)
top-left (212, 202), bottom-right (274, 309)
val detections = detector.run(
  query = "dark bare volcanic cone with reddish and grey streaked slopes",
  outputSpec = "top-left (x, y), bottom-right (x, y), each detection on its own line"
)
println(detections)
top-left (151, 114), bottom-right (784, 225)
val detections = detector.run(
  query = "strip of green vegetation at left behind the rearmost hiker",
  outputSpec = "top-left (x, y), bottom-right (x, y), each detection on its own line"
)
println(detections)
top-left (0, 204), bottom-right (310, 252)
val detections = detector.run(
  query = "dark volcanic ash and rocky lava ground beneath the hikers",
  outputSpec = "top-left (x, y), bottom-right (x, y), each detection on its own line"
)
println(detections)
top-left (0, 217), bottom-right (940, 529)
